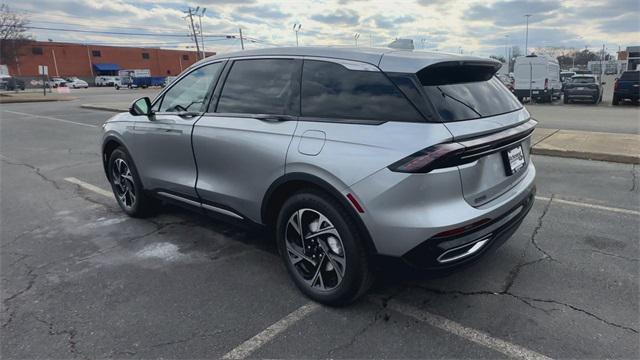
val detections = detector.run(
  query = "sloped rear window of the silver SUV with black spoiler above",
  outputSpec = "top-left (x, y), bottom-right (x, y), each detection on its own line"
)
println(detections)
top-left (418, 65), bottom-right (522, 122)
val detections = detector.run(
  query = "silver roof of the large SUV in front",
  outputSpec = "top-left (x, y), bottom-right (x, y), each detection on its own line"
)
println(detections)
top-left (196, 46), bottom-right (499, 73)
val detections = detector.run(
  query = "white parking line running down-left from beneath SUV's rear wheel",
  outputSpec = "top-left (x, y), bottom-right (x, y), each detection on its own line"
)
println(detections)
top-left (222, 303), bottom-right (320, 359)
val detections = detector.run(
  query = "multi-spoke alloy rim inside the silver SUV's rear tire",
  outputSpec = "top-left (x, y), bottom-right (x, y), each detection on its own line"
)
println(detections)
top-left (284, 209), bottom-right (347, 291)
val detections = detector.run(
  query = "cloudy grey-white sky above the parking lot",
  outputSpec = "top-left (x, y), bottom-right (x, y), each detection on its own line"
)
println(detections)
top-left (6, 0), bottom-right (640, 56)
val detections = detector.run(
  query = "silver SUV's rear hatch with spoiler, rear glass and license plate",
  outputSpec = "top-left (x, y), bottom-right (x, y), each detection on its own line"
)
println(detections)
top-left (417, 61), bottom-right (536, 206)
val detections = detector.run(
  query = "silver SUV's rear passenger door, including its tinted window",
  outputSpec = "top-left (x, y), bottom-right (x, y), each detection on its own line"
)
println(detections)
top-left (193, 58), bottom-right (302, 222)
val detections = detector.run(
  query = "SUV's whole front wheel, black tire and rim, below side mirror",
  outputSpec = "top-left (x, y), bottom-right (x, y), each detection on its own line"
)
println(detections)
top-left (107, 147), bottom-right (158, 217)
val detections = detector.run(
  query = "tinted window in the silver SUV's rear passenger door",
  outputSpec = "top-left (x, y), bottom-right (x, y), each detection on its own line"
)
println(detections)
top-left (216, 59), bottom-right (299, 115)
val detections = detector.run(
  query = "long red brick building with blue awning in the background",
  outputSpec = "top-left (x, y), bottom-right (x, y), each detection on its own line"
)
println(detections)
top-left (1, 41), bottom-right (215, 83)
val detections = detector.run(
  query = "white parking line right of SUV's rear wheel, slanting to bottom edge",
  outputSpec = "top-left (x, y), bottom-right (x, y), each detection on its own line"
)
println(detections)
top-left (387, 301), bottom-right (551, 360)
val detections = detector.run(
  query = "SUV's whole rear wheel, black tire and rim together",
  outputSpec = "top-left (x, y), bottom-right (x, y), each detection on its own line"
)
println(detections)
top-left (276, 190), bottom-right (374, 306)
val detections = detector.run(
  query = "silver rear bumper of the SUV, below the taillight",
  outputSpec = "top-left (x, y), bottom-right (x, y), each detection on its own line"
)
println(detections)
top-left (349, 162), bottom-right (536, 258)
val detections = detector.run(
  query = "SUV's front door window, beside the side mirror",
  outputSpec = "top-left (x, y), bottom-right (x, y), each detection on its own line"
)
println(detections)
top-left (160, 62), bottom-right (223, 112)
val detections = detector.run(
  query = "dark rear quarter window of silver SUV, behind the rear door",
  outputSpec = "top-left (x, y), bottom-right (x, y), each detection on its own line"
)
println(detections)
top-left (301, 60), bottom-right (422, 121)
